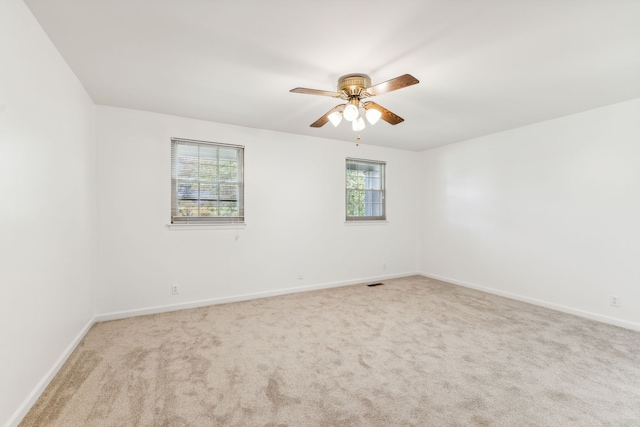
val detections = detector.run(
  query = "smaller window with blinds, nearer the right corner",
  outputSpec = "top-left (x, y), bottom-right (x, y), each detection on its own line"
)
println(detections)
top-left (346, 159), bottom-right (386, 221)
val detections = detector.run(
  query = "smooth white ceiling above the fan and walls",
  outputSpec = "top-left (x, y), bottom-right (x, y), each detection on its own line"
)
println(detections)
top-left (25, 0), bottom-right (640, 151)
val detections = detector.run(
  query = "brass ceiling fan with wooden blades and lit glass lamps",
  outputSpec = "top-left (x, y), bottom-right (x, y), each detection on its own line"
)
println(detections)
top-left (289, 74), bottom-right (420, 131)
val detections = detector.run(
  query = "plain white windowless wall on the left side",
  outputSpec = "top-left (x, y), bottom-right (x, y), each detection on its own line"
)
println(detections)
top-left (0, 0), bottom-right (97, 426)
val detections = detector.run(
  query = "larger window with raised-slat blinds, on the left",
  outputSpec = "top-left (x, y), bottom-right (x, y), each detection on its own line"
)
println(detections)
top-left (171, 138), bottom-right (244, 224)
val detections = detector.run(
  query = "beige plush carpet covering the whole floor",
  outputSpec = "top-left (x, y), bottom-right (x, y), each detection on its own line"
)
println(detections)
top-left (21, 277), bottom-right (640, 427)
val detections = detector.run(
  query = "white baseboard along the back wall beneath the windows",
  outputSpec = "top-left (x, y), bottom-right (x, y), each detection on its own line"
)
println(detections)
top-left (95, 271), bottom-right (419, 322)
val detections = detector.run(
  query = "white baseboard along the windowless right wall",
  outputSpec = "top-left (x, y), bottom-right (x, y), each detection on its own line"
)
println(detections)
top-left (418, 272), bottom-right (640, 331)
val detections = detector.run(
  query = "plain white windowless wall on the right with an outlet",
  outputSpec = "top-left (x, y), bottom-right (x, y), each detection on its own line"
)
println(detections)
top-left (419, 99), bottom-right (640, 329)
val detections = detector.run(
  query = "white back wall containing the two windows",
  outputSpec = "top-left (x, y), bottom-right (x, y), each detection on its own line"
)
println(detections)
top-left (97, 106), bottom-right (417, 318)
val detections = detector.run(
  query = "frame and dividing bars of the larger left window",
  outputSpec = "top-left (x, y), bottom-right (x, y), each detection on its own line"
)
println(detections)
top-left (170, 138), bottom-right (245, 225)
